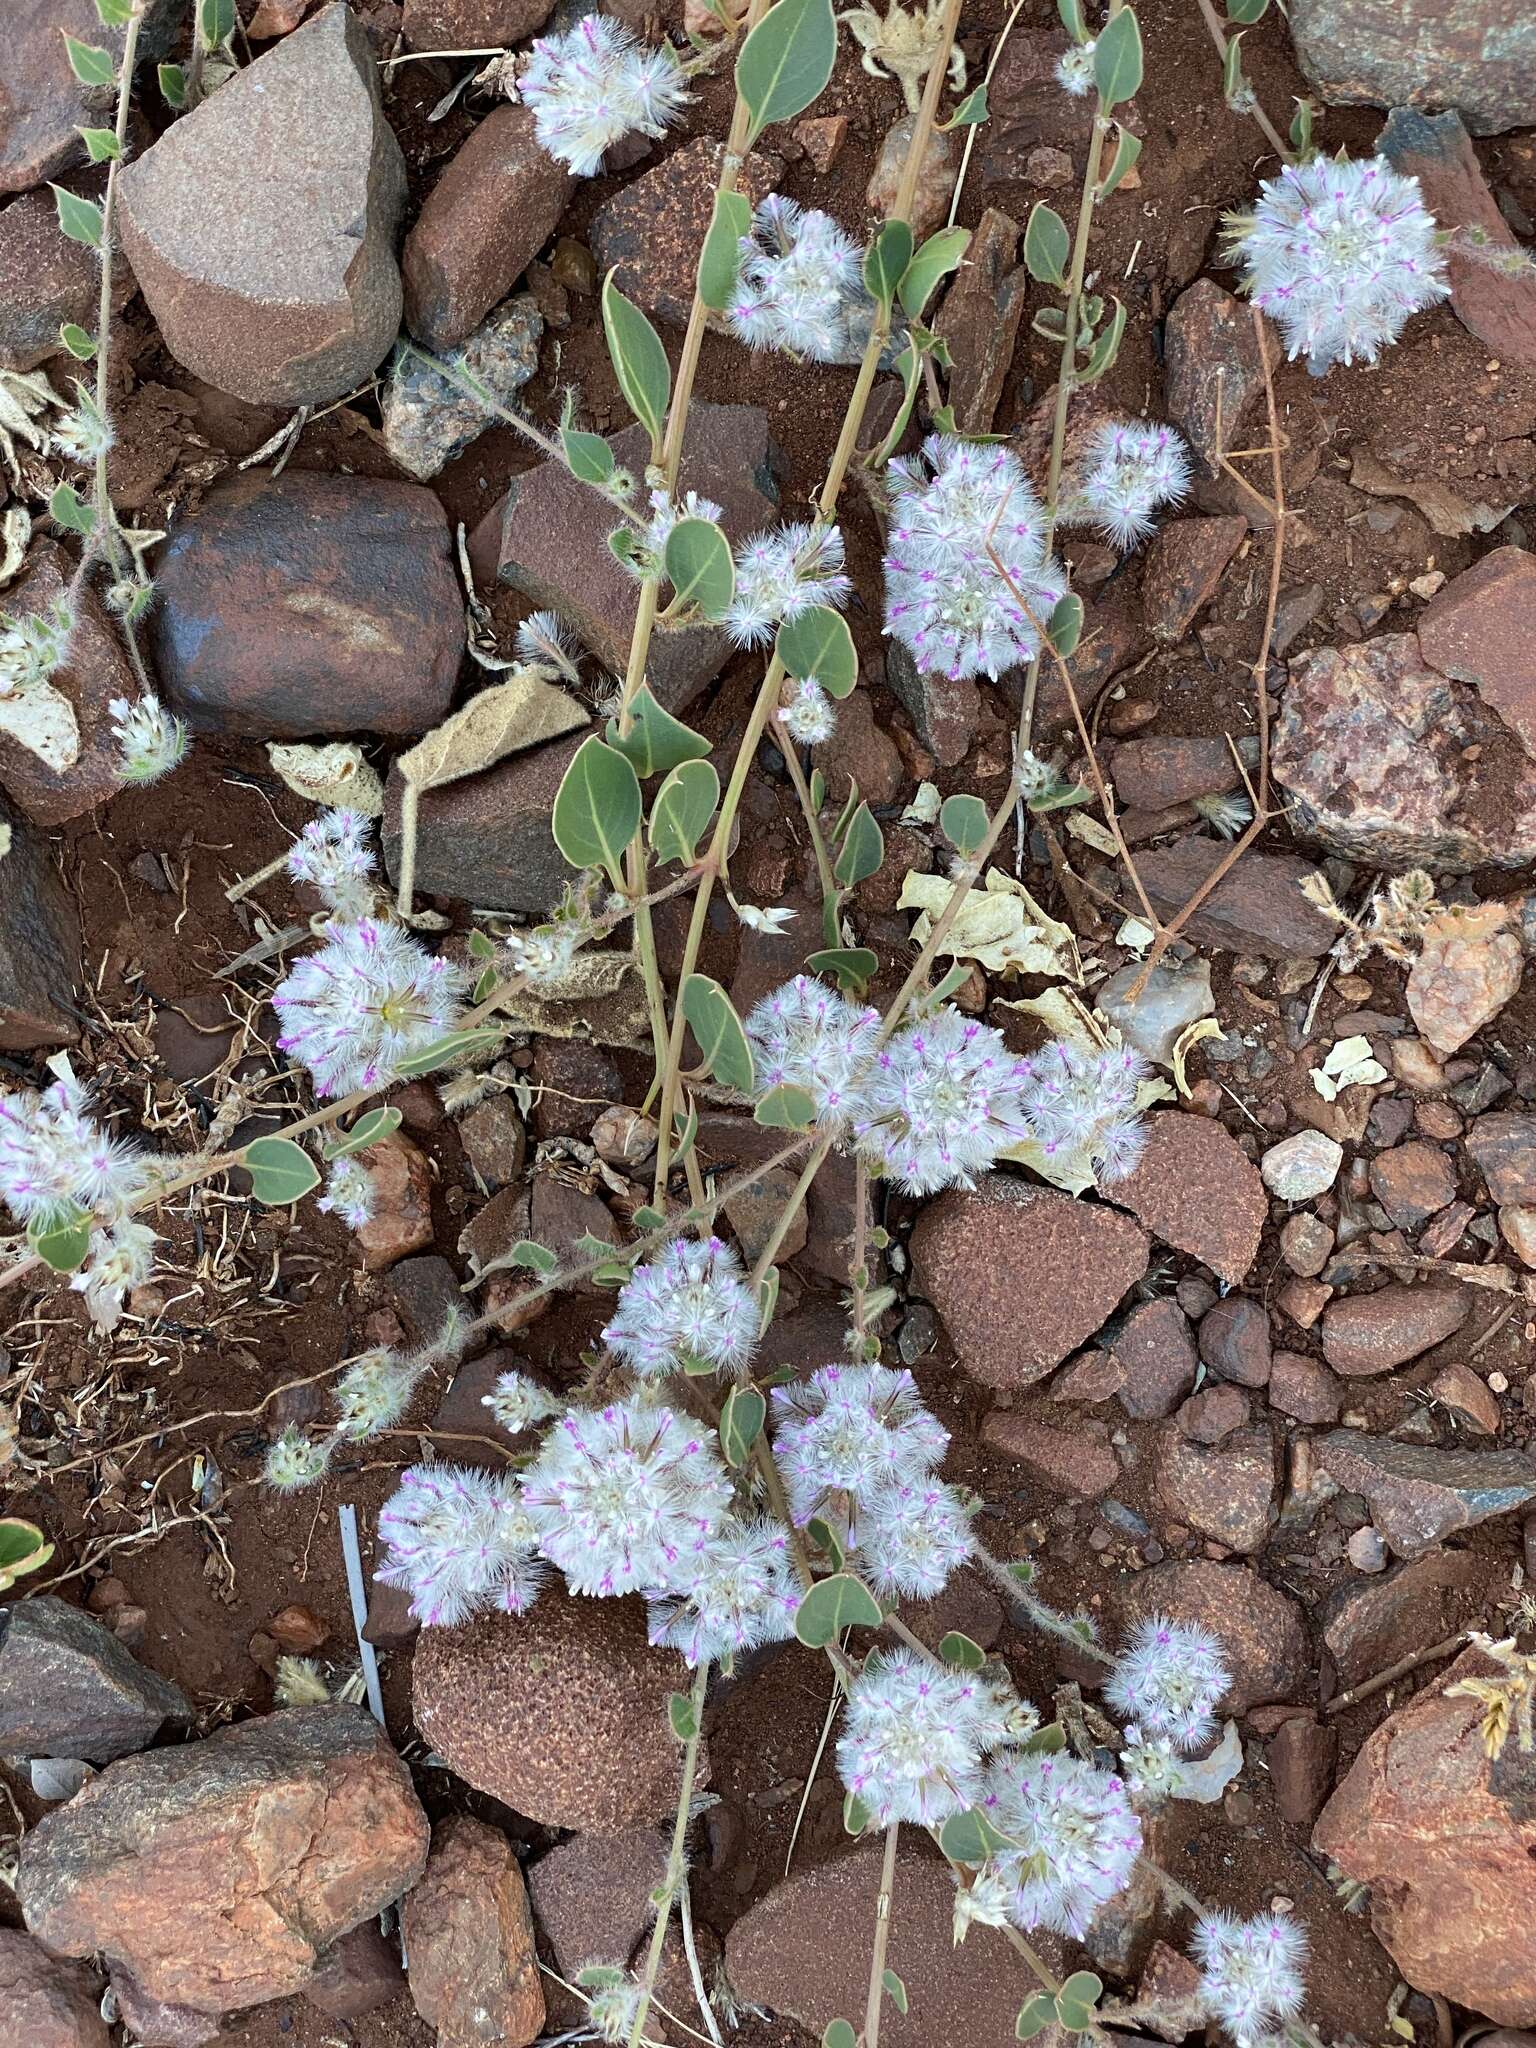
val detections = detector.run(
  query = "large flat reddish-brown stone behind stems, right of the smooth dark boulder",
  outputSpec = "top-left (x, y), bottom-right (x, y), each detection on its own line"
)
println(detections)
top-left (471, 406), bottom-right (776, 713)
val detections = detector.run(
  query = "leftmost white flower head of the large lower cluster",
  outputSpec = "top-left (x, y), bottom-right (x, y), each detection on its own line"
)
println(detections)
top-left (375, 1464), bottom-right (545, 1628)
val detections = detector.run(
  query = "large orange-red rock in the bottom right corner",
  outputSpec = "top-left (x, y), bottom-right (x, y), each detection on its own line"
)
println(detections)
top-left (1313, 1651), bottom-right (1536, 2025)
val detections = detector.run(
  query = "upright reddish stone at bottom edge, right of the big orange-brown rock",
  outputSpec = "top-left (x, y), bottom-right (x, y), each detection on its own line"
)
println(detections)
top-left (401, 1815), bottom-right (545, 2048)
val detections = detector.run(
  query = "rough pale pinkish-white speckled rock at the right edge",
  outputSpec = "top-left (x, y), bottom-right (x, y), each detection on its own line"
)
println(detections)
top-left (1277, 630), bottom-right (1536, 872)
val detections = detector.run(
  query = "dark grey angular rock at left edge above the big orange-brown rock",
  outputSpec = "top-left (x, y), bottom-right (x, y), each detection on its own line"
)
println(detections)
top-left (0, 1593), bottom-right (193, 1763)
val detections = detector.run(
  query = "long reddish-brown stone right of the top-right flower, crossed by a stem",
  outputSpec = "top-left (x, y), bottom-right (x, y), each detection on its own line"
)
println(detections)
top-left (1376, 108), bottom-right (1536, 371)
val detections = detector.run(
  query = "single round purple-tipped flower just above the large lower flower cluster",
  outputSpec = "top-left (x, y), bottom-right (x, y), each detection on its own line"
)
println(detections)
top-left (602, 1237), bottom-right (758, 1378)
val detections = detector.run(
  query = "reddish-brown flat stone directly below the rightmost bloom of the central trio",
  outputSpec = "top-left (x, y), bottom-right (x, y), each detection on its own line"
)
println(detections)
top-left (1108, 1110), bottom-right (1270, 1286)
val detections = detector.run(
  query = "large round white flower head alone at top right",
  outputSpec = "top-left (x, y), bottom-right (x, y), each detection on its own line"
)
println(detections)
top-left (1229, 156), bottom-right (1450, 377)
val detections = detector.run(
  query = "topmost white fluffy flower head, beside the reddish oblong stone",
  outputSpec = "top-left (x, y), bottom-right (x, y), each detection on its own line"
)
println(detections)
top-left (518, 14), bottom-right (690, 178)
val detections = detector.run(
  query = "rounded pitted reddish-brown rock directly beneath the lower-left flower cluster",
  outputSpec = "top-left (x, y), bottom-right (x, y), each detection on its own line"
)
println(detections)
top-left (412, 1585), bottom-right (688, 1833)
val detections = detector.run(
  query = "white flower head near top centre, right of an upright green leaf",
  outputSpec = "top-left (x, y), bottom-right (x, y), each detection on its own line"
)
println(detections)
top-left (725, 193), bottom-right (874, 362)
